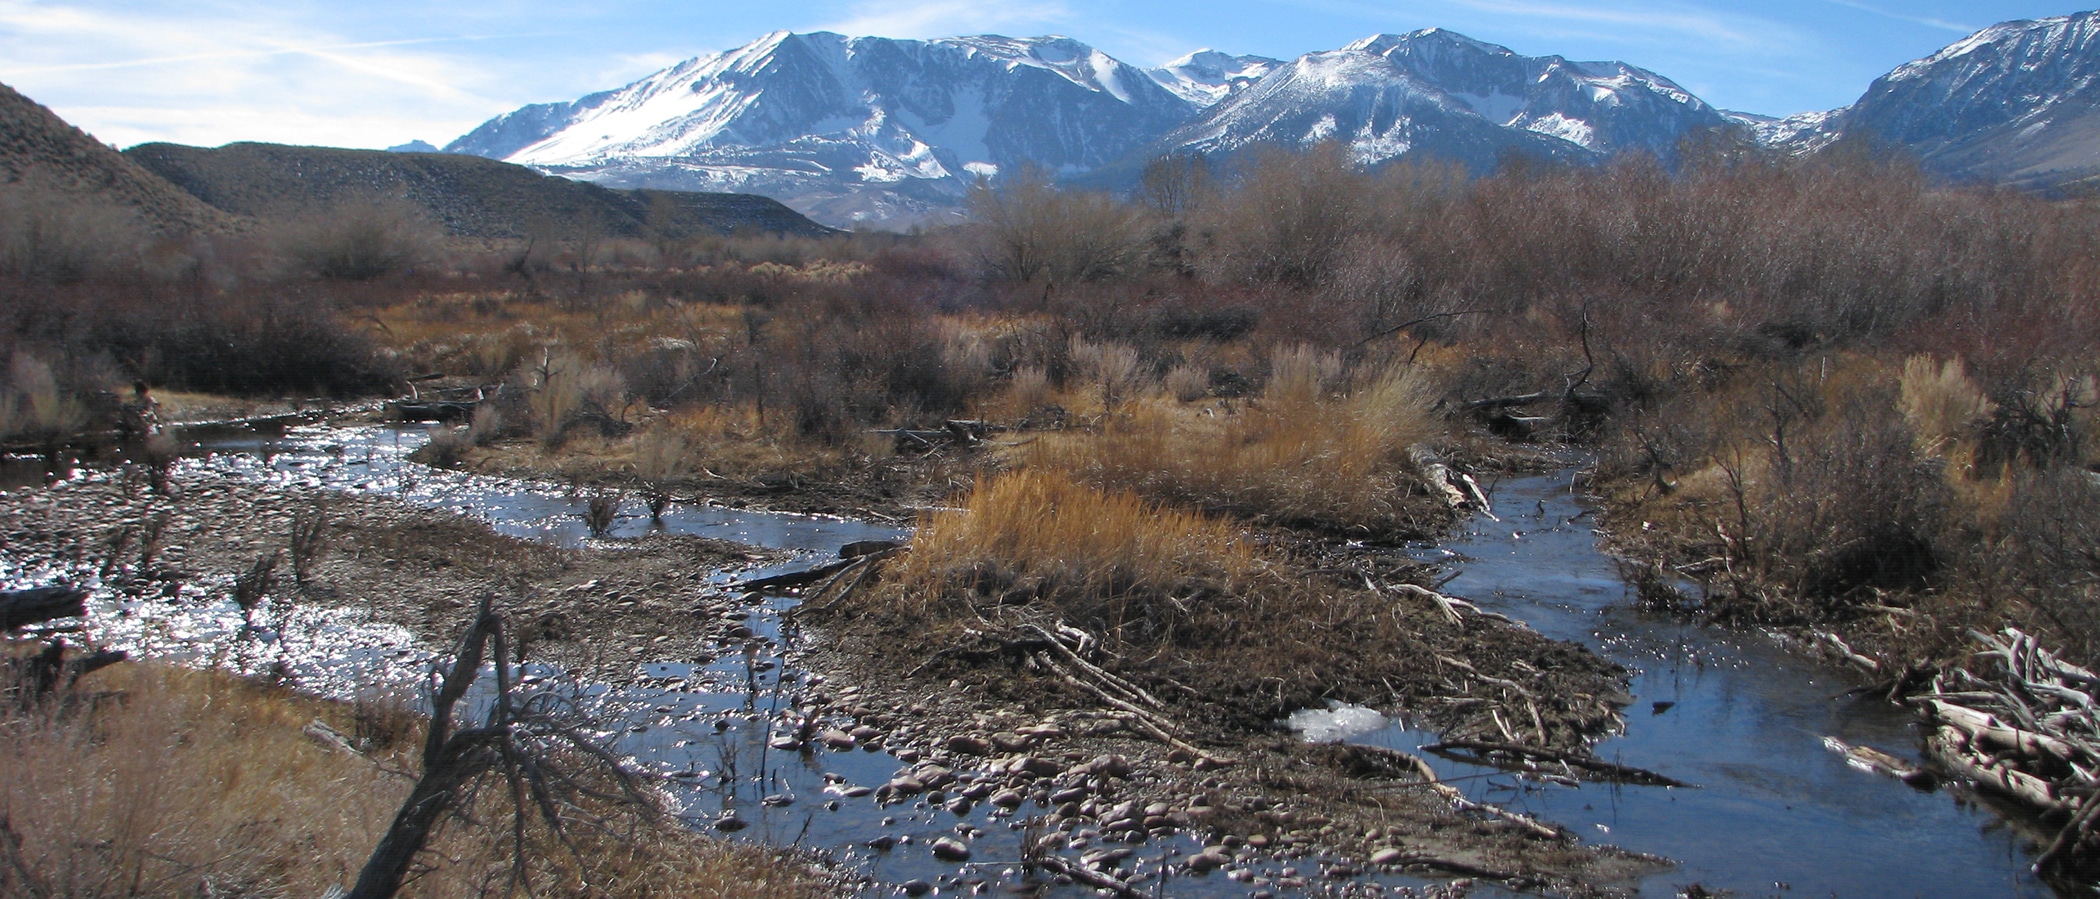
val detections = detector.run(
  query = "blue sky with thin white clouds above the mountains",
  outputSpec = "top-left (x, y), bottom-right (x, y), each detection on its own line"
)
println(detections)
top-left (0, 0), bottom-right (2094, 147)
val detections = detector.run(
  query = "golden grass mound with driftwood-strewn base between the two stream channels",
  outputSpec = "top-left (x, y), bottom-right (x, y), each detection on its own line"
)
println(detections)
top-left (835, 468), bottom-right (1615, 746)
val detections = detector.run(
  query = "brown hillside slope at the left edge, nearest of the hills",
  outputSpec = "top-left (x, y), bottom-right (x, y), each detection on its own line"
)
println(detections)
top-left (0, 84), bottom-right (237, 231)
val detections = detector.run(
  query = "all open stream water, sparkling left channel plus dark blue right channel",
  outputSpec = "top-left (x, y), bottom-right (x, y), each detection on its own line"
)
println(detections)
top-left (0, 422), bottom-right (2052, 897)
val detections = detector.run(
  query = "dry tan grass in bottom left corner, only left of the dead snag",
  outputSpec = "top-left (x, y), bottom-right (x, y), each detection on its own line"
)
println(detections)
top-left (0, 666), bottom-right (410, 897)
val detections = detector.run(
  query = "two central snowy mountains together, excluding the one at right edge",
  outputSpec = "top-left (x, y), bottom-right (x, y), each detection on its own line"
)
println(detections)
top-left (445, 29), bottom-right (1755, 225)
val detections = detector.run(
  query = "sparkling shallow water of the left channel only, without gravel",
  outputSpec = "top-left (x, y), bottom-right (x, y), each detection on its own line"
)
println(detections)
top-left (0, 422), bottom-right (1461, 897)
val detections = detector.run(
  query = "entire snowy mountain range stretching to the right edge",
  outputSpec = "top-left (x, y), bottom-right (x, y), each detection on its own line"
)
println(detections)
top-left (445, 13), bottom-right (2100, 225)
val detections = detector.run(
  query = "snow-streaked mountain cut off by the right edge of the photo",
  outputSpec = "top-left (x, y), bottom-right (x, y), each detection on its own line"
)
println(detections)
top-left (1770, 13), bottom-right (2100, 187)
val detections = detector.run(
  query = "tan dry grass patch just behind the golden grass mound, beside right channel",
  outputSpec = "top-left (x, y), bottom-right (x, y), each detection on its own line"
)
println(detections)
top-left (1023, 361), bottom-right (1443, 538)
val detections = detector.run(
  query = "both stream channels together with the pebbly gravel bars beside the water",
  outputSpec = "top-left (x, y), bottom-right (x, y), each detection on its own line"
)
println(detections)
top-left (0, 428), bottom-right (2050, 897)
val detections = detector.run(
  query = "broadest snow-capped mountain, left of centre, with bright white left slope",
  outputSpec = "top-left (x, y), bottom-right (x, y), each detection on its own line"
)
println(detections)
top-left (445, 32), bottom-right (1195, 223)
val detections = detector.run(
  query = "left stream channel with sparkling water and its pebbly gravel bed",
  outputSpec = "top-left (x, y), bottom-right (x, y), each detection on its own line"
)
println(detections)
top-left (0, 426), bottom-right (1657, 897)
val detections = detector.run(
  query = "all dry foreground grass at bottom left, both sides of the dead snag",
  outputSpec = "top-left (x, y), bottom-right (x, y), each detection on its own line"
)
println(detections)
top-left (0, 664), bottom-right (821, 899)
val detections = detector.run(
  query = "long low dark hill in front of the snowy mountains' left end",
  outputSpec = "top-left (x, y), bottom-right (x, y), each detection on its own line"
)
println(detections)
top-left (124, 143), bottom-right (834, 237)
